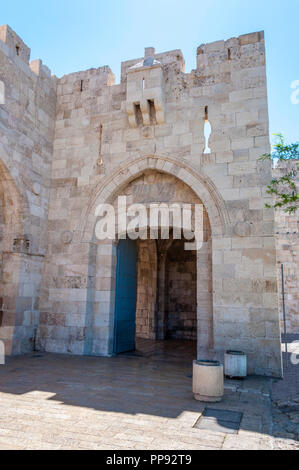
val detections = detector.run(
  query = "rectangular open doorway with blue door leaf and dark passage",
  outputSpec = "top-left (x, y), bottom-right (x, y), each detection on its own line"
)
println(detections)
top-left (113, 233), bottom-right (197, 354)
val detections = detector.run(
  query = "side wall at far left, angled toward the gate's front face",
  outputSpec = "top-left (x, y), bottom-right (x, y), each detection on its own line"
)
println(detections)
top-left (0, 26), bottom-right (56, 354)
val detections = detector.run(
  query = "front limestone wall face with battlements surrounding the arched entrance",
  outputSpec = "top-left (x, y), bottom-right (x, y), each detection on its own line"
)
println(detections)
top-left (34, 28), bottom-right (281, 376)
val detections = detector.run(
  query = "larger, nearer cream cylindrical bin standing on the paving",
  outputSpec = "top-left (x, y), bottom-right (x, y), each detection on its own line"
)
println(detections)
top-left (193, 360), bottom-right (224, 403)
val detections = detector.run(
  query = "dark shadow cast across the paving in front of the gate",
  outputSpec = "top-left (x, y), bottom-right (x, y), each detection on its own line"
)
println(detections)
top-left (0, 336), bottom-right (298, 438)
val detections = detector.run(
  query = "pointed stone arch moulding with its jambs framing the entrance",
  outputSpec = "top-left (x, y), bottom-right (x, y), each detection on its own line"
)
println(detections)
top-left (76, 156), bottom-right (229, 355)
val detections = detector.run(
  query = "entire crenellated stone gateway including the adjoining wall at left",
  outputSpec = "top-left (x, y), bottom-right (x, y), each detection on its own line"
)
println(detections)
top-left (0, 26), bottom-right (292, 377)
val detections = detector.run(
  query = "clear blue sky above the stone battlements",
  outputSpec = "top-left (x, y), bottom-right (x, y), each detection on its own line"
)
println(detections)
top-left (0, 0), bottom-right (299, 141)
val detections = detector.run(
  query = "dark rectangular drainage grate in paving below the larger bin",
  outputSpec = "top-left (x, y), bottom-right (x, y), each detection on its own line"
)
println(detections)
top-left (194, 408), bottom-right (243, 434)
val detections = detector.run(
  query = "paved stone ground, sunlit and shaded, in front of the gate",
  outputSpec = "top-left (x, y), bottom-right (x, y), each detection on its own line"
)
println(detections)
top-left (0, 349), bottom-right (299, 450)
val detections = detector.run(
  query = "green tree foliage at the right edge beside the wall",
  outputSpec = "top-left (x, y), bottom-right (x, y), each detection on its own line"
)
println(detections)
top-left (261, 134), bottom-right (299, 214)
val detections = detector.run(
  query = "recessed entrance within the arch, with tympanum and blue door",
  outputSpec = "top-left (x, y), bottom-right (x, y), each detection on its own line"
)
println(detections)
top-left (88, 170), bottom-right (213, 355)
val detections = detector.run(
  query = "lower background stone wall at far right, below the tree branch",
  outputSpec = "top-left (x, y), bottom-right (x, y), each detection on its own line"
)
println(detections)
top-left (273, 161), bottom-right (299, 334)
